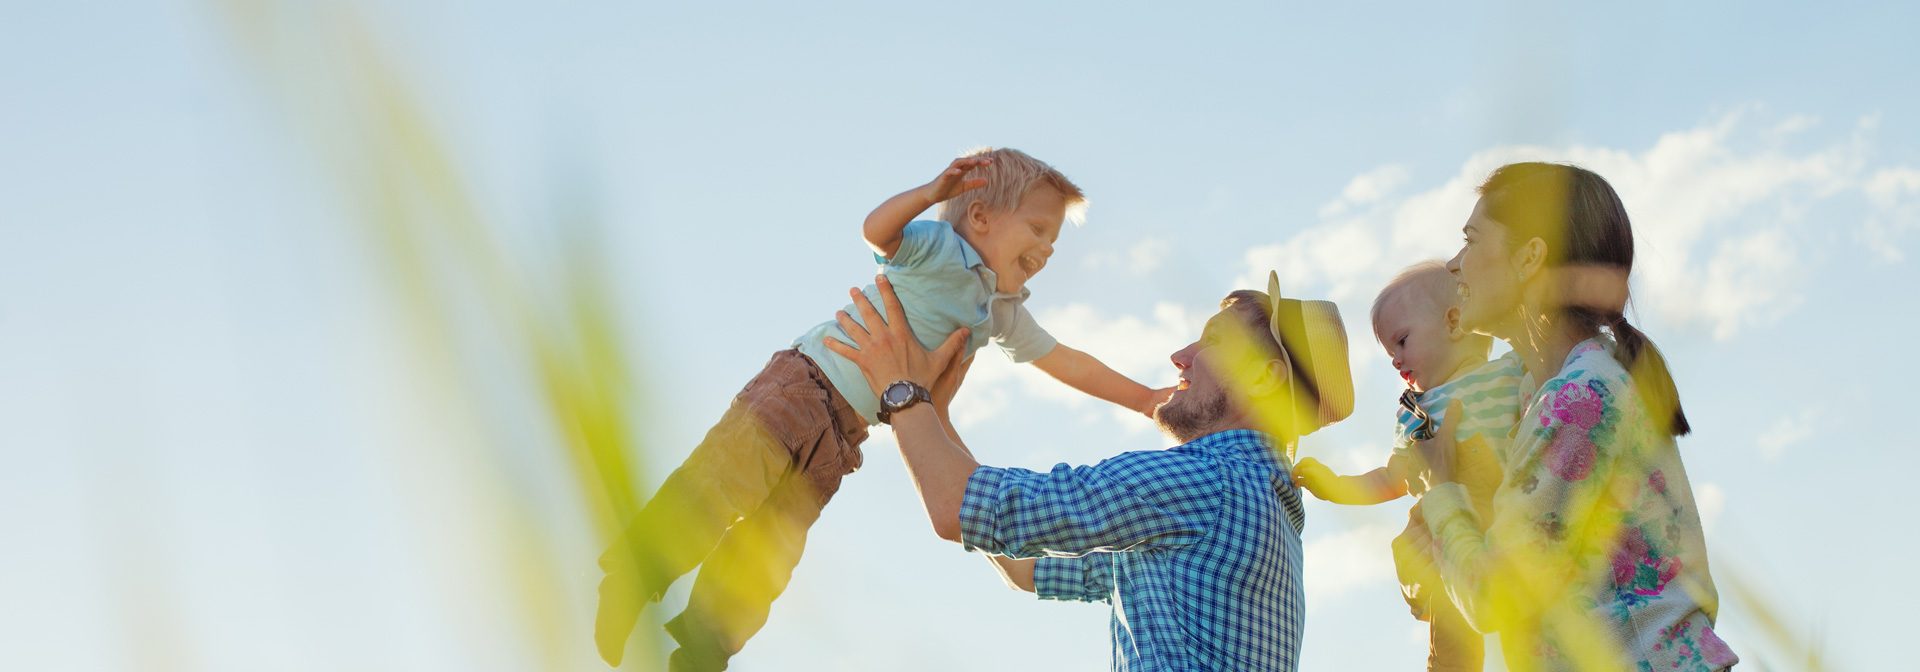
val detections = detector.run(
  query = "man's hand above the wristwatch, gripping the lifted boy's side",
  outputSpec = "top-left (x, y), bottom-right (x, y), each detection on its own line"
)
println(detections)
top-left (826, 275), bottom-right (968, 396)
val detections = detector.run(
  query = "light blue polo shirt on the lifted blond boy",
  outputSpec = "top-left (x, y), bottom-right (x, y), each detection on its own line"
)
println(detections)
top-left (793, 221), bottom-right (1058, 424)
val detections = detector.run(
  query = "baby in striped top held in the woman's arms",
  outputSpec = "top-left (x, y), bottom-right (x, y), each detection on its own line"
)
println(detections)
top-left (1294, 261), bottom-right (1521, 670)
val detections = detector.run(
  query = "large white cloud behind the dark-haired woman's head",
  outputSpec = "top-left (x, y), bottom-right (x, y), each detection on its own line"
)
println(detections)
top-left (1238, 111), bottom-right (1920, 340)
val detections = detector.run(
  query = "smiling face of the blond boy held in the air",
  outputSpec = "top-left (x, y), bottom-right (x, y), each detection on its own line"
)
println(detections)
top-left (968, 186), bottom-right (1068, 294)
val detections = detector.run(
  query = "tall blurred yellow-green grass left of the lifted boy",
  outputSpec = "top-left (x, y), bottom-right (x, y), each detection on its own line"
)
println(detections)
top-left (219, 0), bottom-right (657, 666)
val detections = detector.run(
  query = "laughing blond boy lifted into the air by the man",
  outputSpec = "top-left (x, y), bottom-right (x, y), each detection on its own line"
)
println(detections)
top-left (595, 148), bottom-right (1169, 670)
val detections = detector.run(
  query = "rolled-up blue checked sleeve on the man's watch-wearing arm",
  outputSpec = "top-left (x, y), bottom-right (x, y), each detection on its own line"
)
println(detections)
top-left (960, 451), bottom-right (1223, 559)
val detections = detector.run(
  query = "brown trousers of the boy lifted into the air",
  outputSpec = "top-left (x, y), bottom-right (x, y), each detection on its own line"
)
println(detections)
top-left (601, 349), bottom-right (866, 670)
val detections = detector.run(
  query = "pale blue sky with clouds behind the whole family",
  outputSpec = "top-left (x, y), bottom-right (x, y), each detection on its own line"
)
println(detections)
top-left (0, 2), bottom-right (1920, 670)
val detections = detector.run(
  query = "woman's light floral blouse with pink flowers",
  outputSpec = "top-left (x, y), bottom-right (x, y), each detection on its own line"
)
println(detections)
top-left (1442, 340), bottom-right (1740, 672)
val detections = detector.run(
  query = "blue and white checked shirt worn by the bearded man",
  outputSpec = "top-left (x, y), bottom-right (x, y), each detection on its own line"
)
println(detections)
top-left (960, 430), bottom-right (1306, 670)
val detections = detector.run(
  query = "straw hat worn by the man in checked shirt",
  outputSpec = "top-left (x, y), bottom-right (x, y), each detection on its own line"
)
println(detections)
top-left (1267, 271), bottom-right (1354, 436)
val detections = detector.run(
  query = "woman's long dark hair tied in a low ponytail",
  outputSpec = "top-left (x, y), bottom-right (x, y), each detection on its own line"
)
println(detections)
top-left (1480, 163), bottom-right (1692, 436)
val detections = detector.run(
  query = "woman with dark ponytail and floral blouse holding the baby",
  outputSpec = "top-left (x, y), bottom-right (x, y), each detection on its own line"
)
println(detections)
top-left (1402, 163), bottom-right (1738, 670)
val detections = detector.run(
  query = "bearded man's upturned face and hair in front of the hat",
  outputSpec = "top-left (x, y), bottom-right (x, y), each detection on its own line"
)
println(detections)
top-left (1154, 307), bottom-right (1250, 444)
